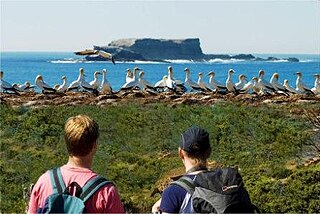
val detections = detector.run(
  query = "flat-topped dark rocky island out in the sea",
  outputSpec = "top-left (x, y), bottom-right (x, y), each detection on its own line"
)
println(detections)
top-left (85, 38), bottom-right (299, 62)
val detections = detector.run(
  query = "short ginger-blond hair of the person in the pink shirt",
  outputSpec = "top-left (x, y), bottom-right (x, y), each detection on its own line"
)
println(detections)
top-left (64, 115), bottom-right (99, 156)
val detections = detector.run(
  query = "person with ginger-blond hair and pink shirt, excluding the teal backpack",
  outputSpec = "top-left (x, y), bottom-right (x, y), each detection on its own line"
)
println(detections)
top-left (28, 115), bottom-right (124, 213)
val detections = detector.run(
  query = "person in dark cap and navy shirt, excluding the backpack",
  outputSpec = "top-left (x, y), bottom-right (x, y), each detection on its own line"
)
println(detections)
top-left (152, 126), bottom-right (211, 213)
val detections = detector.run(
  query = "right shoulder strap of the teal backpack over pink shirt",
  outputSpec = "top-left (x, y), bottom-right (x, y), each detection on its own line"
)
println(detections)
top-left (79, 175), bottom-right (113, 202)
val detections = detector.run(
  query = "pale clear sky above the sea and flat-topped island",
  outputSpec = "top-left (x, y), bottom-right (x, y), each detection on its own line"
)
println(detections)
top-left (0, 0), bottom-right (320, 54)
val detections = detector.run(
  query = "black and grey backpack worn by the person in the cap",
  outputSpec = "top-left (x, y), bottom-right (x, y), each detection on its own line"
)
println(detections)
top-left (172, 168), bottom-right (260, 213)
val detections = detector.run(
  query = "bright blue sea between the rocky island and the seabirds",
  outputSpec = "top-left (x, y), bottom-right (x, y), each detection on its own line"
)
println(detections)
top-left (0, 52), bottom-right (320, 90)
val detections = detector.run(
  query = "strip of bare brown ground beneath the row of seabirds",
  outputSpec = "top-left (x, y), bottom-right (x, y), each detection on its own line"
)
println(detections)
top-left (0, 91), bottom-right (320, 107)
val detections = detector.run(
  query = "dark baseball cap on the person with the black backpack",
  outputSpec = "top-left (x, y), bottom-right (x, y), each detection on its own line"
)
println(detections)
top-left (180, 126), bottom-right (211, 154)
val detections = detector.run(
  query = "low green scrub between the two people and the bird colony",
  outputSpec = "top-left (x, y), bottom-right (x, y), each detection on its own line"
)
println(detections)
top-left (0, 103), bottom-right (320, 213)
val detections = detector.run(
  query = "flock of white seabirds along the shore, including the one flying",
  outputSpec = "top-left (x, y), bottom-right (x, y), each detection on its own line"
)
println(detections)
top-left (0, 49), bottom-right (320, 96)
